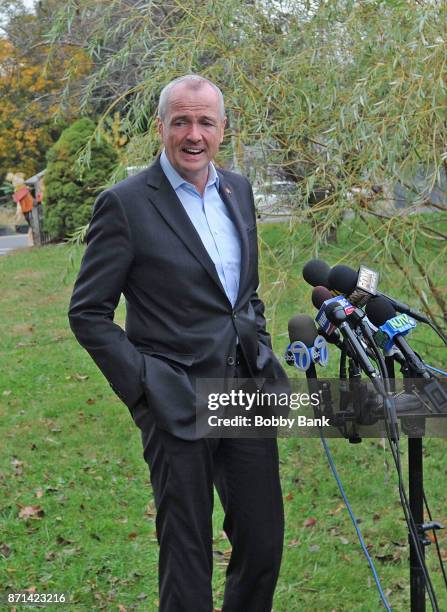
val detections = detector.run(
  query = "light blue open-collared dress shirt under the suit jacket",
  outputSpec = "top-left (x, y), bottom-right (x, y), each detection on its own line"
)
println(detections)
top-left (160, 150), bottom-right (241, 306)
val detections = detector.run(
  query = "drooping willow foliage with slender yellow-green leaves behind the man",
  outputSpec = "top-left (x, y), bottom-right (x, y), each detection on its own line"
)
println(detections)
top-left (49, 0), bottom-right (447, 326)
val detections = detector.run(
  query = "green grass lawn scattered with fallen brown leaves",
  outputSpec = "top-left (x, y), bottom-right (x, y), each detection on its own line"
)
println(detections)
top-left (0, 219), bottom-right (447, 612)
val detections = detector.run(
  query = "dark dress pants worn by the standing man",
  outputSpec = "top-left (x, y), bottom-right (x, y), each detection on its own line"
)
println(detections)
top-left (135, 356), bottom-right (284, 612)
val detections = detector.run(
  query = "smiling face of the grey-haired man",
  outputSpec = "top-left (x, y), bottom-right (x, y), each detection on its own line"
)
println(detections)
top-left (157, 83), bottom-right (226, 189)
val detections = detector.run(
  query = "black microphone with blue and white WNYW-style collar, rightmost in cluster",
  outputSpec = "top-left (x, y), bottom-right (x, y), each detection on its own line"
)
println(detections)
top-left (366, 296), bottom-right (432, 379)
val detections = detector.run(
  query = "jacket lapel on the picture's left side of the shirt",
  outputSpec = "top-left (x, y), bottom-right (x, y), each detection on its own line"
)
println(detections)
top-left (147, 160), bottom-right (226, 296)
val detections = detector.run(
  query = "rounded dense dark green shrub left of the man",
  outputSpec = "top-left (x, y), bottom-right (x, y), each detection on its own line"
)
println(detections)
top-left (45, 118), bottom-right (117, 238)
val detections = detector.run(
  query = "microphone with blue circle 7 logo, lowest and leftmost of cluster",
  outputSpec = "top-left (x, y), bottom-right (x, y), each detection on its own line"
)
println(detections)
top-left (286, 315), bottom-right (329, 377)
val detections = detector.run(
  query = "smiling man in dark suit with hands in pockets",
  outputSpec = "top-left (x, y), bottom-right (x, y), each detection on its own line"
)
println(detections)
top-left (69, 75), bottom-right (287, 612)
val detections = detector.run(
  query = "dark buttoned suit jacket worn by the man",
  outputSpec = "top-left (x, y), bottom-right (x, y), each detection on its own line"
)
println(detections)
top-left (69, 155), bottom-right (287, 439)
